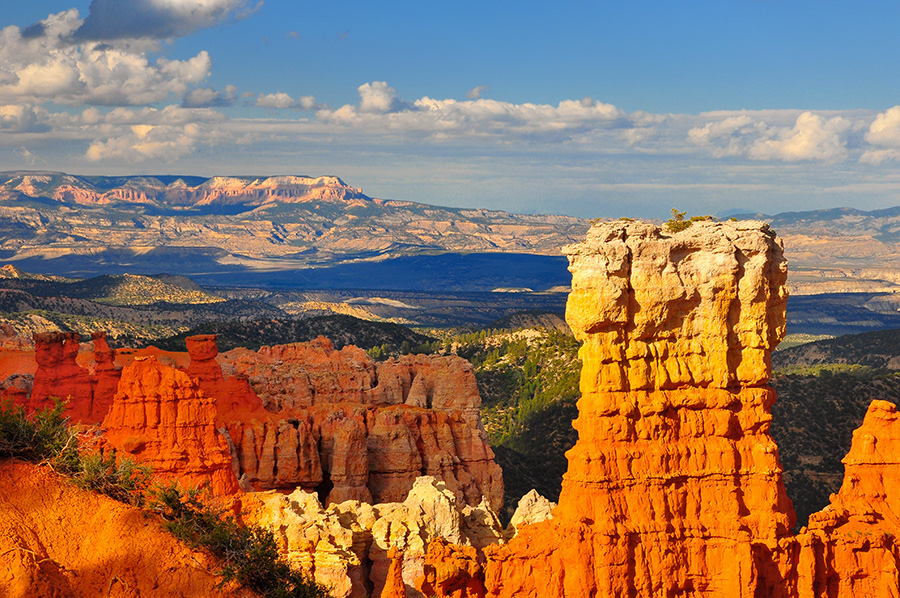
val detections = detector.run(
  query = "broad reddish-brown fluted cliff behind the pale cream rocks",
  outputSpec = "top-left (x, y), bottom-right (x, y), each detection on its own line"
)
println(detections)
top-left (216, 337), bottom-right (503, 509)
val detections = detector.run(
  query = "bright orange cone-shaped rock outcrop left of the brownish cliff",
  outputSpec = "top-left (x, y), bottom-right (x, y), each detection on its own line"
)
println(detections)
top-left (101, 357), bottom-right (238, 494)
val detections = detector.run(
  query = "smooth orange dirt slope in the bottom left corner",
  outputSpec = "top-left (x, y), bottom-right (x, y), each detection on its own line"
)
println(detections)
top-left (0, 460), bottom-right (255, 598)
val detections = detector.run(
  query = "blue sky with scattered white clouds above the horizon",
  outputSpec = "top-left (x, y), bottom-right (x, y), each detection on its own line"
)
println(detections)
top-left (0, 0), bottom-right (900, 217)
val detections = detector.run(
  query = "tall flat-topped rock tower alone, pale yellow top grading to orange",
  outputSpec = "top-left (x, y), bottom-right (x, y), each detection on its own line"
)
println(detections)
top-left (557, 222), bottom-right (794, 597)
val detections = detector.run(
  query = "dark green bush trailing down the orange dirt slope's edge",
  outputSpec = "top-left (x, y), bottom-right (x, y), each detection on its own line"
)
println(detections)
top-left (149, 483), bottom-right (328, 598)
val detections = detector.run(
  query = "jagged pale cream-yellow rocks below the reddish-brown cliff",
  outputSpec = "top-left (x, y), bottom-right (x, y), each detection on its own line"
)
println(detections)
top-left (244, 476), bottom-right (502, 598)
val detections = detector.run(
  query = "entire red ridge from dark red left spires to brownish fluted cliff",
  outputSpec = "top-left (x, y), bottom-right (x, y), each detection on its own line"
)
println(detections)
top-left (3, 333), bottom-right (503, 509)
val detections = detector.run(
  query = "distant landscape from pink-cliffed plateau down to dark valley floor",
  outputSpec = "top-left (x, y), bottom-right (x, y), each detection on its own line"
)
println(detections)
top-left (0, 172), bottom-right (900, 336)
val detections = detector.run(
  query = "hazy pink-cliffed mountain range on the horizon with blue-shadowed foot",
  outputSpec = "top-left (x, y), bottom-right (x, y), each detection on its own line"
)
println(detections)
top-left (0, 171), bottom-right (900, 295)
